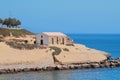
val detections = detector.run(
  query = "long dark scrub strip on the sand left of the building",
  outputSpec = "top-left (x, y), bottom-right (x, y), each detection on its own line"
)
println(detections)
top-left (6, 42), bottom-right (38, 50)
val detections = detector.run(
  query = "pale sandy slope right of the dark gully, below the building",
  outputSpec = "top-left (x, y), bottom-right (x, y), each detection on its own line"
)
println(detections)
top-left (56, 44), bottom-right (107, 64)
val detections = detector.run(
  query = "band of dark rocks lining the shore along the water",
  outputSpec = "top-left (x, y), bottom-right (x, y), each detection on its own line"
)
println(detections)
top-left (0, 58), bottom-right (120, 74)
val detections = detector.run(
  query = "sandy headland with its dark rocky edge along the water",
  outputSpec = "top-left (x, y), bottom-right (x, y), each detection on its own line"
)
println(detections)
top-left (0, 42), bottom-right (114, 74)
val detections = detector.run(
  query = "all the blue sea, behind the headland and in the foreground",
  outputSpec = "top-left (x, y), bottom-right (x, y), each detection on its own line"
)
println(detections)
top-left (0, 34), bottom-right (120, 80)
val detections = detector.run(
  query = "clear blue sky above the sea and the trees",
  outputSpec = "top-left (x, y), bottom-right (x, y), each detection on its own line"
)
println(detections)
top-left (0, 0), bottom-right (120, 33)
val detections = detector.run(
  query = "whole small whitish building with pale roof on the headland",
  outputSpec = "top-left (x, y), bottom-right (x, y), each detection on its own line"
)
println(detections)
top-left (36, 32), bottom-right (73, 45)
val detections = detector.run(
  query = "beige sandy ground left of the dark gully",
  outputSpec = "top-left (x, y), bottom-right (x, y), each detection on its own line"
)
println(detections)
top-left (0, 42), bottom-right (54, 66)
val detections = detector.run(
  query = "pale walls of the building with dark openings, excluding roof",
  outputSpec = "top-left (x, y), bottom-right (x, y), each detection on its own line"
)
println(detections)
top-left (36, 33), bottom-right (72, 45)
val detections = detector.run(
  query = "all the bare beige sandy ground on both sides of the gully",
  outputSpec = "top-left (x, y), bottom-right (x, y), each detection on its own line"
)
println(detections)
top-left (0, 42), bottom-right (106, 68)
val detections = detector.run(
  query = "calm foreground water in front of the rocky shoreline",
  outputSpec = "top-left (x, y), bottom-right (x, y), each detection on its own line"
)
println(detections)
top-left (0, 68), bottom-right (120, 80)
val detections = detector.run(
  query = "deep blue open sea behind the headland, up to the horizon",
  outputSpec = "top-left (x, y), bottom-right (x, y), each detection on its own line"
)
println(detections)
top-left (69, 34), bottom-right (120, 58)
